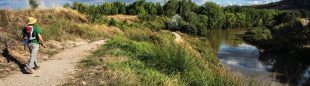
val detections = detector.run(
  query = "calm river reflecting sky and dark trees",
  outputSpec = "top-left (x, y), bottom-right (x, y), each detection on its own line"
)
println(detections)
top-left (208, 29), bottom-right (310, 86)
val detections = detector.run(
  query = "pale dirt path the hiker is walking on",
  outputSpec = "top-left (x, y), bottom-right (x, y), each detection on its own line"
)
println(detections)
top-left (0, 40), bottom-right (105, 86)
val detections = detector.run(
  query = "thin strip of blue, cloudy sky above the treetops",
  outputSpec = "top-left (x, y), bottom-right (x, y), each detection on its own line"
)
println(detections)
top-left (0, 0), bottom-right (280, 9)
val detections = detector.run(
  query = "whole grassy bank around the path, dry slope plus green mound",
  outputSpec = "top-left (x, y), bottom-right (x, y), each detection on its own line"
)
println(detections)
top-left (0, 9), bottom-right (238, 85)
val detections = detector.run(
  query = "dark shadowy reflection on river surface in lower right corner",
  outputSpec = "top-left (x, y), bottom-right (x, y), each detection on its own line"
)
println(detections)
top-left (259, 51), bottom-right (310, 86)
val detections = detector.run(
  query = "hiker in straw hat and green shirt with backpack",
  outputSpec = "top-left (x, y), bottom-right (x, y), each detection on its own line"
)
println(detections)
top-left (22, 17), bottom-right (45, 74)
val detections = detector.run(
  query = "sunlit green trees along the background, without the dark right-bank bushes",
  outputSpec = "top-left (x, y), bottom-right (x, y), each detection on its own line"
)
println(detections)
top-left (67, 0), bottom-right (290, 36)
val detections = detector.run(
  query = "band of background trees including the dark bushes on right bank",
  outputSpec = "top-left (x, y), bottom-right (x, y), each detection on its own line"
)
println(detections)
top-left (67, 0), bottom-right (310, 47)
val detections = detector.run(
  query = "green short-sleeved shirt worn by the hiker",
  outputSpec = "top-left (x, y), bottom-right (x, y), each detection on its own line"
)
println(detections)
top-left (22, 25), bottom-right (41, 44)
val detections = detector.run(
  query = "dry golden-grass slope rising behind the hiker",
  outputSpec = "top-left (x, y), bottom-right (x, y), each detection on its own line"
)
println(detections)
top-left (0, 8), bottom-right (118, 78)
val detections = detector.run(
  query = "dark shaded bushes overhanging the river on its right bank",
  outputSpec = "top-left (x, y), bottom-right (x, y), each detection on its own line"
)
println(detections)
top-left (245, 12), bottom-right (309, 52)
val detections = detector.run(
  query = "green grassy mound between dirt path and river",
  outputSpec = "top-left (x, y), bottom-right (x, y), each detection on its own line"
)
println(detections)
top-left (64, 25), bottom-right (236, 86)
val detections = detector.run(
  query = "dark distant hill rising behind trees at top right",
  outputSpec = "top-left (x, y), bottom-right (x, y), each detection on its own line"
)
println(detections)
top-left (254, 0), bottom-right (310, 10)
